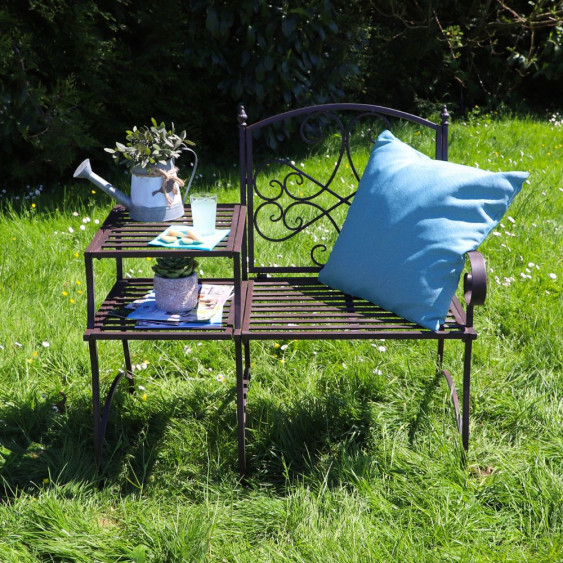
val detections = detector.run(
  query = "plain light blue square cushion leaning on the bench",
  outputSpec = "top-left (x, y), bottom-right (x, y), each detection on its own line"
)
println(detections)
top-left (319, 131), bottom-right (528, 330)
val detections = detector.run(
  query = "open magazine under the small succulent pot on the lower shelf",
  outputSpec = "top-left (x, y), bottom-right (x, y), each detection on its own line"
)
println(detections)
top-left (113, 283), bottom-right (234, 328)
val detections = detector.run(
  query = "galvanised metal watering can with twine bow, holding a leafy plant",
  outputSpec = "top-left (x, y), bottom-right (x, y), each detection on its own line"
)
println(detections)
top-left (73, 149), bottom-right (198, 222)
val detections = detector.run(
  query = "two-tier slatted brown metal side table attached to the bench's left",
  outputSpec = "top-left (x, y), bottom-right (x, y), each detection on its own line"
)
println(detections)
top-left (84, 204), bottom-right (246, 472)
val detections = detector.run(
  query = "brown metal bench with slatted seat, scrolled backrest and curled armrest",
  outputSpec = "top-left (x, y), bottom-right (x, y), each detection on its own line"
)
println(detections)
top-left (236, 104), bottom-right (486, 472)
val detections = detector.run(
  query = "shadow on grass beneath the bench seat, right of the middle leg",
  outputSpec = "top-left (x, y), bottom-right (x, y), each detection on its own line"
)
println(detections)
top-left (247, 368), bottom-right (463, 488)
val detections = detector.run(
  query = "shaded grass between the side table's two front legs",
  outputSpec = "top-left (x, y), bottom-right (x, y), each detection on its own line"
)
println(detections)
top-left (101, 385), bottom-right (237, 494)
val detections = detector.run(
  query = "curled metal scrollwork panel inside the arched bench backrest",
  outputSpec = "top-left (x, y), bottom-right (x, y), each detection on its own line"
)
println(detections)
top-left (246, 104), bottom-right (442, 273)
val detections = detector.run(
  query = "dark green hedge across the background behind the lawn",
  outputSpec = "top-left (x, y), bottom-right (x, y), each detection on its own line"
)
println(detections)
top-left (0, 0), bottom-right (563, 190)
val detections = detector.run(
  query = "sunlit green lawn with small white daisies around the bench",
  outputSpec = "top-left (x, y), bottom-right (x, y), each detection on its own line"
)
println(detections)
top-left (0, 116), bottom-right (563, 562)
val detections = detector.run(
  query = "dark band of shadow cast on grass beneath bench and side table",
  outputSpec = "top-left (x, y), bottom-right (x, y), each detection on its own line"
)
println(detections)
top-left (0, 368), bottom-right (458, 501)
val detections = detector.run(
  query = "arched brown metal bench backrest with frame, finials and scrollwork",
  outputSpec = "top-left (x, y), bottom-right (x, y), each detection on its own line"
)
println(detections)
top-left (238, 104), bottom-right (449, 277)
